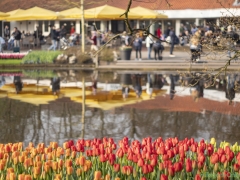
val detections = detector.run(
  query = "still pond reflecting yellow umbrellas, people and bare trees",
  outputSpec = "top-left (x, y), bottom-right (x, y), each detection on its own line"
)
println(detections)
top-left (0, 70), bottom-right (240, 144)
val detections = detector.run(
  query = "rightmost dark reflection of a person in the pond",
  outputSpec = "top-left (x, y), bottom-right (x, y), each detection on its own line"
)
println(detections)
top-left (225, 75), bottom-right (236, 105)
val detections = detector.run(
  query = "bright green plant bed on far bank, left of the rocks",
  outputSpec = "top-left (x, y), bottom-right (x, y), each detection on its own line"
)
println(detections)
top-left (22, 51), bottom-right (62, 64)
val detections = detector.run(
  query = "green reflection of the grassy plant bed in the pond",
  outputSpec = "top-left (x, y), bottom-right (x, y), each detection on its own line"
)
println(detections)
top-left (22, 69), bottom-right (56, 78)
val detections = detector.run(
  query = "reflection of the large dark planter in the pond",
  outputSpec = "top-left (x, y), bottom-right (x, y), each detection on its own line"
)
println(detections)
top-left (120, 74), bottom-right (132, 99)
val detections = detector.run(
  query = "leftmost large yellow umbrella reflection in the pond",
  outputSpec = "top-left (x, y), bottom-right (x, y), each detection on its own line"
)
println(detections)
top-left (8, 92), bottom-right (58, 106)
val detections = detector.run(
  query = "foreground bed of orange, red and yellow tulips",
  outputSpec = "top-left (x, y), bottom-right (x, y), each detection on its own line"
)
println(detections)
top-left (0, 137), bottom-right (240, 180)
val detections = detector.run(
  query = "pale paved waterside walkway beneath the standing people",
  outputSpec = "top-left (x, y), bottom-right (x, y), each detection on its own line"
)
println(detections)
top-left (98, 47), bottom-right (240, 70)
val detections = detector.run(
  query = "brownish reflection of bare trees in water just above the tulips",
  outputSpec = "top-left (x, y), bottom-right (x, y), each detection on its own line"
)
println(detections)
top-left (0, 99), bottom-right (240, 144)
